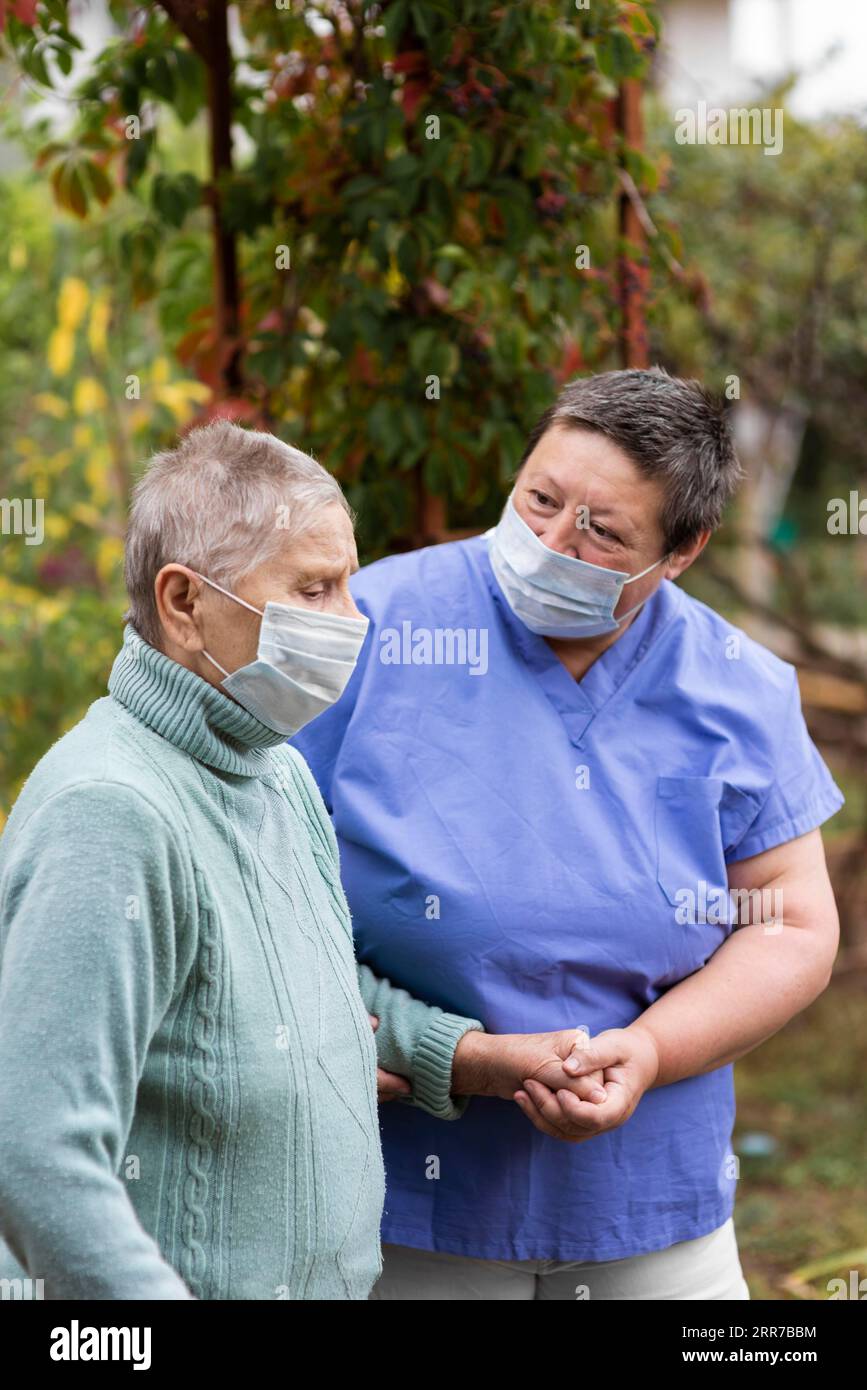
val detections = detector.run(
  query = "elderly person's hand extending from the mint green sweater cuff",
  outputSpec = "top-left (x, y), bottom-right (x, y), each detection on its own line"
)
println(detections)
top-left (452, 1029), bottom-right (607, 1109)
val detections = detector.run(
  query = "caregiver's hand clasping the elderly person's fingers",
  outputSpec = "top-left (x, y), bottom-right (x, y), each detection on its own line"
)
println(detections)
top-left (514, 1023), bottom-right (659, 1144)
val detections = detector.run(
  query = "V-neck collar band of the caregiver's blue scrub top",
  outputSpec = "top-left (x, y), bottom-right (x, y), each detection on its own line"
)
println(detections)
top-left (471, 537), bottom-right (682, 746)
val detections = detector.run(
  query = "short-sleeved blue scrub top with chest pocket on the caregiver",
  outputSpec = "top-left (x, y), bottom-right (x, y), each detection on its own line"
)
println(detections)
top-left (293, 537), bottom-right (843, 1261)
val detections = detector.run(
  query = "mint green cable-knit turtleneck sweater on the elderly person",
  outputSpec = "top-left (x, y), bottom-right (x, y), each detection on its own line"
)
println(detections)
top-left (0, 627), bottom-right (482, 1298)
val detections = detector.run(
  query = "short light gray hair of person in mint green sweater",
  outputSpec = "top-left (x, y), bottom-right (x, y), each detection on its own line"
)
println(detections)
top-left (124, 420), bottom-right (352, 646)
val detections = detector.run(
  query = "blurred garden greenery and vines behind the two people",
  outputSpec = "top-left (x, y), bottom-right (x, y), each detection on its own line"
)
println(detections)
top-left (0, 0), bottom-right (867, 1298)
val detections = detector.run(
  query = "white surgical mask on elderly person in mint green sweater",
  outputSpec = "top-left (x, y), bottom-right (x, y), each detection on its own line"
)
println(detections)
top-left (193, 570), bottom-right (370, 737)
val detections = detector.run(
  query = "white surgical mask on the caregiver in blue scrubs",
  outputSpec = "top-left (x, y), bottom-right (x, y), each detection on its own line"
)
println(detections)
top-left (485, 493), bottom-right (668, 637)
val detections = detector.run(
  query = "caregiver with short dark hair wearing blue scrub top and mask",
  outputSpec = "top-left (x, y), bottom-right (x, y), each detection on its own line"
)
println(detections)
top-left (295, 370), bottom-right (842, 1300)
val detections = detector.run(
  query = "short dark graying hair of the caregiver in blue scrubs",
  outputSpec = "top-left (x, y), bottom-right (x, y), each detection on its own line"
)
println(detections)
top-left (518, 367), bottom-right (742, 550)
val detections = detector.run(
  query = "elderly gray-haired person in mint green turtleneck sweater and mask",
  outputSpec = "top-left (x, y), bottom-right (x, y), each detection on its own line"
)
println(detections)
top-left (0, 423), bottom-right (604, 1300)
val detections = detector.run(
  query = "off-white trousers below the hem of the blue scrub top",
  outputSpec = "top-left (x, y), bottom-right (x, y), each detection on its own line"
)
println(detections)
top-left (370, 1218), bottom-right (750, 1302)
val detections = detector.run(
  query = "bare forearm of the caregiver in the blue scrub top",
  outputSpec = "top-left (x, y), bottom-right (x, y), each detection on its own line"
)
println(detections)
top-left (629, 924), bottom-right (834, 1087)
